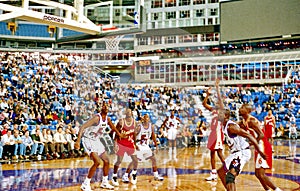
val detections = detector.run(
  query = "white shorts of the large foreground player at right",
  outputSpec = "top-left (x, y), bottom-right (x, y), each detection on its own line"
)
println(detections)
top-left (225, 149), bottom-right (251, 172)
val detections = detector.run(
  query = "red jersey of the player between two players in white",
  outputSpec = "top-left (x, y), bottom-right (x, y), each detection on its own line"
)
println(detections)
top-left (117, 119), bottom-right (135, 148)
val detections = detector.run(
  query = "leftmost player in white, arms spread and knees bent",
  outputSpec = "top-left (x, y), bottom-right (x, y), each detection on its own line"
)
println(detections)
top-left (74, 102), bottom-right (124, 191)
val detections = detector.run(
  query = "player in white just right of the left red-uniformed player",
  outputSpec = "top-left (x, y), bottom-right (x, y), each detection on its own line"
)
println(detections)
top-left (119, 114), bottom-right (164, 181)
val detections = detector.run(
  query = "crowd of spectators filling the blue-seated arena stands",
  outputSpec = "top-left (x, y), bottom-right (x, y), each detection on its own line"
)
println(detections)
top-left (0, 52), bottom-right (300, 160)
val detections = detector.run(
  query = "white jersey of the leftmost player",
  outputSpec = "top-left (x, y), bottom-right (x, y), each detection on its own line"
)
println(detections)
top-left (83, 113), bottom-right (108, 140)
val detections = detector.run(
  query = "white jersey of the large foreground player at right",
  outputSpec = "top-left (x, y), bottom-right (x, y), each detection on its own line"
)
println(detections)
top-left (224, 120), bottom-right (249, 153)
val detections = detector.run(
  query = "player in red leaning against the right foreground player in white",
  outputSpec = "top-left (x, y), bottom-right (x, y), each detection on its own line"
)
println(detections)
top-left (239, 104), bottom-right (281, 191)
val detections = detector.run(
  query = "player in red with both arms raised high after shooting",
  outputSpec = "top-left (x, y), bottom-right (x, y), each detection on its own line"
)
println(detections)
top-left (203, 79), bottom-right (225, 181)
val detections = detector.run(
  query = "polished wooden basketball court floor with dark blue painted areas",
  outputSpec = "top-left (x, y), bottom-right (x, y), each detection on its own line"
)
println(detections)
top-left (0, 140), bottom-right (300, 191)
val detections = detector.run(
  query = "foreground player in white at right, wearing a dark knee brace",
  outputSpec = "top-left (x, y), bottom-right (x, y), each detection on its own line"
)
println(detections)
top-left (218, 110), bottom-right (266, 191)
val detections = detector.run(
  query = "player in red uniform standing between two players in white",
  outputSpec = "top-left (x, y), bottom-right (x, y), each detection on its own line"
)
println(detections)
top-left (112, 108), bottom-right (138, 186)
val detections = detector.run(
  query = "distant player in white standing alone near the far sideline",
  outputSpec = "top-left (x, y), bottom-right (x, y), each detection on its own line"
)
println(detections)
top-left (162, 110), bottom-right (181, 159)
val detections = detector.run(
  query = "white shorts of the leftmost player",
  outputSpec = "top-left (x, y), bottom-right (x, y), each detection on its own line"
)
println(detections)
top-left (82, 137), bottom-right (105, 156)
